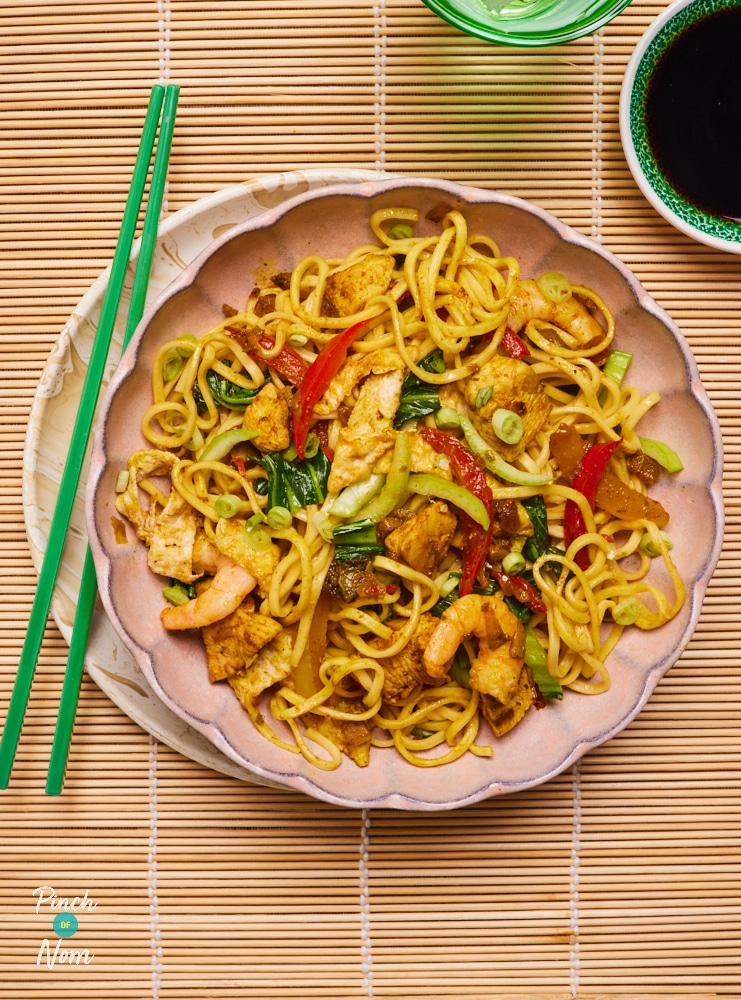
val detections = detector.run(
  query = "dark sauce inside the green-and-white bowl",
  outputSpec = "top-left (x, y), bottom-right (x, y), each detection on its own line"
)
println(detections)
top-left (646, 7), bottom-right (741, 219)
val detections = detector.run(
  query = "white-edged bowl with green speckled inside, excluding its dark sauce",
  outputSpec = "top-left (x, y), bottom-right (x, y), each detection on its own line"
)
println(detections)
top-left (620, 0), bottom-right (741, 253)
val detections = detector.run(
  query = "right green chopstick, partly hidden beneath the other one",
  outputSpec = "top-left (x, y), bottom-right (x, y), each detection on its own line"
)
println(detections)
top-left (46, 85), bottom-right (180, 795)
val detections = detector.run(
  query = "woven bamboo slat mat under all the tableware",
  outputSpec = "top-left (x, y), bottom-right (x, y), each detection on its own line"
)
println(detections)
top-left (0, 0), bottom-right (741, 1000)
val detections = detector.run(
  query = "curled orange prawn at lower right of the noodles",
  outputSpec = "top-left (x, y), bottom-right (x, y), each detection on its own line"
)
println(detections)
top-left (424, 594), bottom-right (525, 704)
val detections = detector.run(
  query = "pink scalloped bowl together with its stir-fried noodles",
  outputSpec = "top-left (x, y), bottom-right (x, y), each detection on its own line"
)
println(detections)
top-left (87, 178), bottom-right (723, 809)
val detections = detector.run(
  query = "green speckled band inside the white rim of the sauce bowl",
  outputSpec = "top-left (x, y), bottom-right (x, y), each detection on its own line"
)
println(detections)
top-left (630, 0), bottom-right (741, 243)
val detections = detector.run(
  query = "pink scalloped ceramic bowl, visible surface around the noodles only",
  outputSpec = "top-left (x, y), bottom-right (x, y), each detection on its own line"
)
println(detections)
top-left (86, 178), bottom-right (723, 810)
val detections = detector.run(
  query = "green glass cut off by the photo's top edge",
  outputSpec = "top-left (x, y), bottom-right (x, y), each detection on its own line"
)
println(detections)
top-left (423, 0), bottom-right (630, 47)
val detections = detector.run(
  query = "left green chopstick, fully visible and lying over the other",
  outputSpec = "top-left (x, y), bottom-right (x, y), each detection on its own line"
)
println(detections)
top-left (0, 85), bottom-right (172, 788)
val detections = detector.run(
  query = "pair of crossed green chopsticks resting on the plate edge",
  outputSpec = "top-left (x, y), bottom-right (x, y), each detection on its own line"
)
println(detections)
top-left (0, 84), bottom-right (180, 795)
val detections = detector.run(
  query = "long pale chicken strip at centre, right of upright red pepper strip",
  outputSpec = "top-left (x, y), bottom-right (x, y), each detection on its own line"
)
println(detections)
top-left (328, 371), bottom-right (404, 493)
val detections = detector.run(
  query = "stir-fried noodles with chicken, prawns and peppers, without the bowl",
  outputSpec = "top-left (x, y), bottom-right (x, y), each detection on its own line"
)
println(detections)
top-left (114, 206), bottom-right (684, 769)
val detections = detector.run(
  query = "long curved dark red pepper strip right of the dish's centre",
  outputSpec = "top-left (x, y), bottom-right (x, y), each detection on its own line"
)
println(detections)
top-left (419, 426), bottom-right (494, 597)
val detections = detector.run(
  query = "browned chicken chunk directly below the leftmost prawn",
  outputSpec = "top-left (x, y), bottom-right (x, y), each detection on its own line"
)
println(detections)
top-left (201, 598), bottom-right (283, 683)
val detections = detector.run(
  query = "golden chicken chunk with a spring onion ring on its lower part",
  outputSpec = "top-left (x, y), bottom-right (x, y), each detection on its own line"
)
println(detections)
top-left (465, 355), bottom-right (551, 462)
